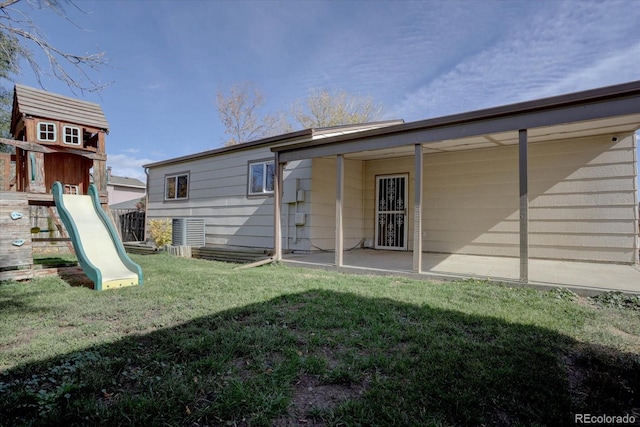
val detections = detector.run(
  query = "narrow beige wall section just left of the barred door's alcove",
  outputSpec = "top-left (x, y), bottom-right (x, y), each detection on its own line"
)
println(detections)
top-left (309, 159), bottom-right (364, 250)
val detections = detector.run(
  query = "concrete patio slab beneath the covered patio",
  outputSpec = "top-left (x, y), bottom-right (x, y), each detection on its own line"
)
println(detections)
top-left (283, 249), bottom-right (640, 295)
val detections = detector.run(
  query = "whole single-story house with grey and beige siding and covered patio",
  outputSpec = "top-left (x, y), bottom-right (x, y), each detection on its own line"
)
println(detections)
top-left (147, 81), bottom-right (640, 291)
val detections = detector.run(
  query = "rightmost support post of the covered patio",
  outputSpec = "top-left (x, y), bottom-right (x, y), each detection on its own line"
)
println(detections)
top-left (518, 129), bottom-right (529, 283)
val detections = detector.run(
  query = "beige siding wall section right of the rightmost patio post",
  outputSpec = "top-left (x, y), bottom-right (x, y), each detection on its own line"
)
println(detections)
top-left (529, 135), bottom-right (637, 263)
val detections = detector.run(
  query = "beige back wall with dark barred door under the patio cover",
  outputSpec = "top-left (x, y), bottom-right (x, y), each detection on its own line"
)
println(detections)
top-left (302, 135), bottom-right (638, 264)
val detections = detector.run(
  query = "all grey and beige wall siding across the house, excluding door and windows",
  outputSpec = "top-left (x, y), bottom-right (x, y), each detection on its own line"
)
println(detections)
top-left (149, 135), bottom-right (638, 263)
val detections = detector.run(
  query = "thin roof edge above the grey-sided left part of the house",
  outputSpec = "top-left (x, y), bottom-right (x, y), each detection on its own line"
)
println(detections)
top-left (142, 119), bottom-right (404, 168)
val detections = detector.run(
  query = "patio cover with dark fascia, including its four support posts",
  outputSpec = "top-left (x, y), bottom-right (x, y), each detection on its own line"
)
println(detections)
top-left (271, 81), bottom-right (640, 283)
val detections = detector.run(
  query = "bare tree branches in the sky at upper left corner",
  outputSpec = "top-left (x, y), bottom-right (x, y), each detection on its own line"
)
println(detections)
top-left (0, 0), bottom-right (108, 92)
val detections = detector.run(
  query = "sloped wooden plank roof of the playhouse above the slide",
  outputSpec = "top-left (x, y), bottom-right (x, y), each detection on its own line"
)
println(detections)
top-left (11, 84), bottom-right (109, 132)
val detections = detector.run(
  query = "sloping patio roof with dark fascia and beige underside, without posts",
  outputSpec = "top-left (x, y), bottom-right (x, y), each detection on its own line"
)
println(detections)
top-left (272, 81), bottom-right (640, 163)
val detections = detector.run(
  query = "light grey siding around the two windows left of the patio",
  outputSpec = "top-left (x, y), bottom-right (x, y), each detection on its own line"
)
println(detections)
top-left (148, 147), bottom-right (310, 249)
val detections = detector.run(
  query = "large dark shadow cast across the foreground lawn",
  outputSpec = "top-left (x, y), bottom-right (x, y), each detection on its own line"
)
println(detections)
top-left (0, 290), bottom-right (640, 426)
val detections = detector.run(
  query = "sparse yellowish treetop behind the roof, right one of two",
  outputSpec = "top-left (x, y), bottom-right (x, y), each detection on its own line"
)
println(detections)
top-left (291, 89), bottom-right (383, 129)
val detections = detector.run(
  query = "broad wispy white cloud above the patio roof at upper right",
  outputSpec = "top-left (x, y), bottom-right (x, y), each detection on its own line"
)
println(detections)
top-left (394, 2), bottom-right (640, 120)
